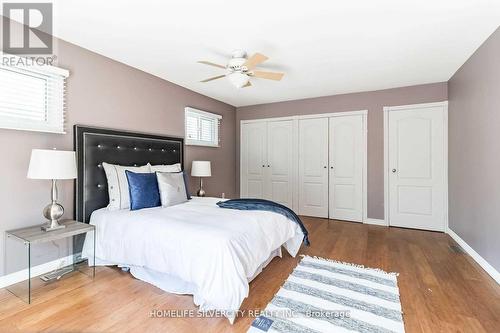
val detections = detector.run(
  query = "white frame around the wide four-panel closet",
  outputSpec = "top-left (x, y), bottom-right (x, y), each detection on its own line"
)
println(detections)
top-left (239, 110), bottom-right (373, 223)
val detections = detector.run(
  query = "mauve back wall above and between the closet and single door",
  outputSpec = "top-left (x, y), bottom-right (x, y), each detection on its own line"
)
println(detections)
top-left (236, 82), bottom-right (447, 219)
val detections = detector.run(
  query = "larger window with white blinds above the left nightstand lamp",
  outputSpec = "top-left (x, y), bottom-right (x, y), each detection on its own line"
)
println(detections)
top-left (0, 60), bottom-right (68, 133)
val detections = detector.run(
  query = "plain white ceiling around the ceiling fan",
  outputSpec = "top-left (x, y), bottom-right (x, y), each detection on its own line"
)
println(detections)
top-left (49, 0), bottom-right (500, 106)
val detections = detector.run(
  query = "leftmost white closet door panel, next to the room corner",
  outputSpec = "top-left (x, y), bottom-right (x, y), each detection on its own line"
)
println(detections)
top-left (240, 122), bottom-right (267, 199)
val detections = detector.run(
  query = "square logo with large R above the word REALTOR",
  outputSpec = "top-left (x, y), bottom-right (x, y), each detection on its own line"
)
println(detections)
top-left (2, 2), bottom-right (52, 54)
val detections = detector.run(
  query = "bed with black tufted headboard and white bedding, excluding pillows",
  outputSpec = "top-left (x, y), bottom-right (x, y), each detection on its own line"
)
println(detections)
top-left (74, 125), bottom-right (304, 323)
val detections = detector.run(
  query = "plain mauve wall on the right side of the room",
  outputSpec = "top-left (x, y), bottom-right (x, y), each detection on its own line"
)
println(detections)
top-left (448, 29), bottom-right (500, 271)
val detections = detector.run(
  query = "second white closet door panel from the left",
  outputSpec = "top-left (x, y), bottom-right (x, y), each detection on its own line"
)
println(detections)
top-left (264, 120), bottom-right (296, 208)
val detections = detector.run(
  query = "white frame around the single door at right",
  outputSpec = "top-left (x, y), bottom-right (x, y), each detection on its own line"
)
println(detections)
top-left (384, 101), bottom-right (448, 228)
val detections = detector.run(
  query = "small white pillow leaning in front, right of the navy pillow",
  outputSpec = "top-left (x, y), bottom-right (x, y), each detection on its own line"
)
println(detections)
top-left (156, 172), bottom-right (187, 207)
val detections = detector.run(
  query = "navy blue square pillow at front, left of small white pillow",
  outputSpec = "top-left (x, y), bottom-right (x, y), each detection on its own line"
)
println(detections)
top-left (125, 170), bottom-right (161, 210)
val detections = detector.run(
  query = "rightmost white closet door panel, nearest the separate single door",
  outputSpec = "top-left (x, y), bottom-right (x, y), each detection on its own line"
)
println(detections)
top-left (329, 115), bottom-right (364, 222)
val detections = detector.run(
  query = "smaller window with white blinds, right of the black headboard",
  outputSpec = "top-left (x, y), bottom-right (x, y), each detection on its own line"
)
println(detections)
top-left (185, 107), bottom-right (222, 147)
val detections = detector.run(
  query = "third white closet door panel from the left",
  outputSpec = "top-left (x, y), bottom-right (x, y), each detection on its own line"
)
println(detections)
top-left (299, 118), bottom-right (328, 217)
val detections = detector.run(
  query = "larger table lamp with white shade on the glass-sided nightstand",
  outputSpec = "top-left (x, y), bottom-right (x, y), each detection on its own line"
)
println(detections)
top-left (28, 149), bottom-right (77, 231)
